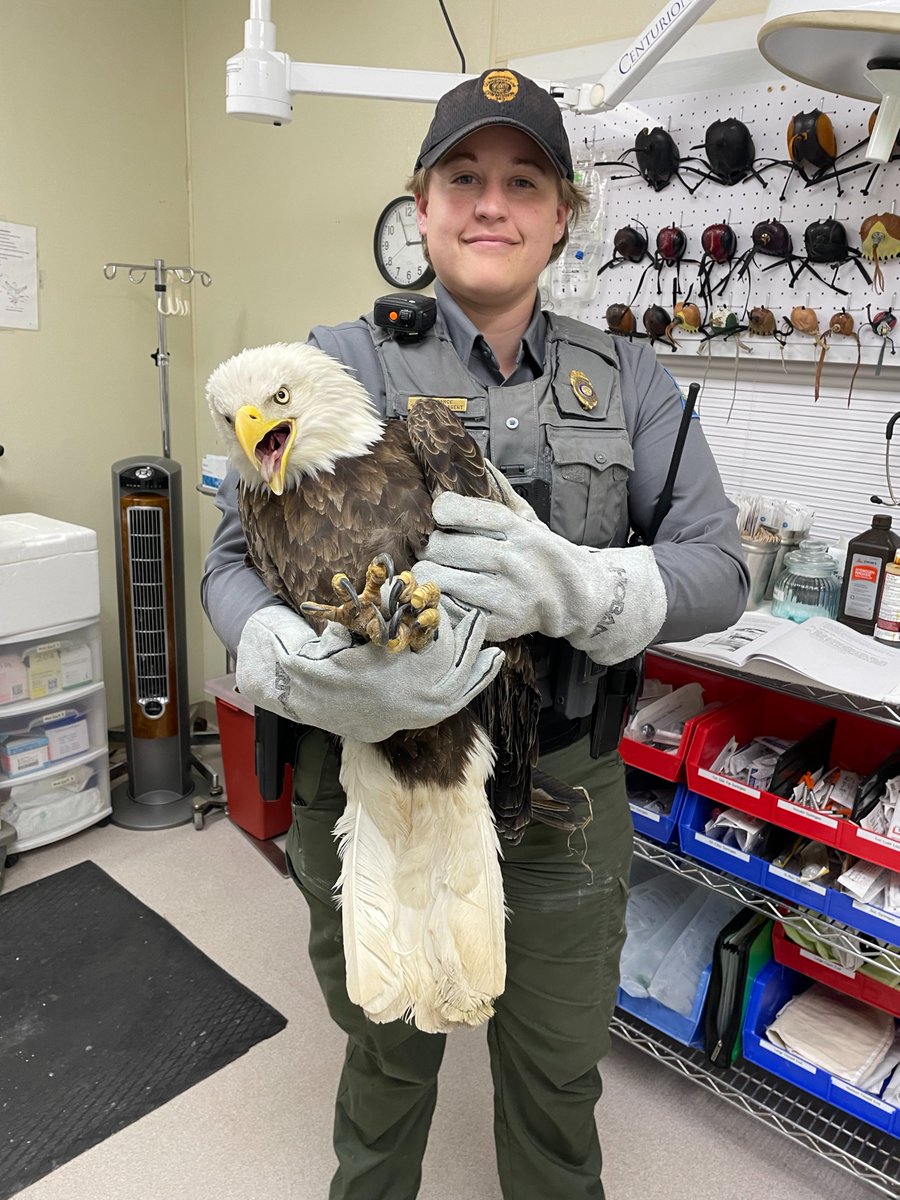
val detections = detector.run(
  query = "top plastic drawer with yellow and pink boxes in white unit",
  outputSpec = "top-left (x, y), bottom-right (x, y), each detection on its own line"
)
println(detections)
top-left (0, 622), bottom-right (103, 705)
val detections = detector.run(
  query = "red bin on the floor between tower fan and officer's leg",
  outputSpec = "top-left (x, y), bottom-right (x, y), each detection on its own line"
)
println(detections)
top-left (206, 674), bottom-right (293, 840)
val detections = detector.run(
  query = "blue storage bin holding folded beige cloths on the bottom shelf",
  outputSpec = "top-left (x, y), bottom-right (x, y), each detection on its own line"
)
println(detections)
top-left (743, 961), bottom-right (900, 1138)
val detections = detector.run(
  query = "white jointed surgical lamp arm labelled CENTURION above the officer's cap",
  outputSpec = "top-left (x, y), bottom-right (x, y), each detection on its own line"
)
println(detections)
top-left (226, 0), bottom-right (715, 125)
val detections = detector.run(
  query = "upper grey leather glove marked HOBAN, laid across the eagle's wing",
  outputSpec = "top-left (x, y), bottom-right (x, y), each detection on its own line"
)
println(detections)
top-left (415, 492), bottom-right (667, 665)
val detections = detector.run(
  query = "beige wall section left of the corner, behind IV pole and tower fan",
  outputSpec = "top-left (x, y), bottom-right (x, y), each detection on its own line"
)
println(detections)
top-left (0, 0), bottom-right (202, 721)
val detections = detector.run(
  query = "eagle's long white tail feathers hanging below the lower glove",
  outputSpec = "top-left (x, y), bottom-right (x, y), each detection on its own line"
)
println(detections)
top-left (335, 730), bottom-right (505, 1033)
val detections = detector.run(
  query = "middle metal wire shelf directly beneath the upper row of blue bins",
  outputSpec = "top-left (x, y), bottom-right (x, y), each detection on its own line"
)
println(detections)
top-left (635, 833), bottom-right (900, 979)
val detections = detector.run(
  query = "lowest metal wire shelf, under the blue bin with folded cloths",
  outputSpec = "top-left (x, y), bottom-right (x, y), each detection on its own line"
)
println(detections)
top-left (611, 1009), bottom-right (900, 1200)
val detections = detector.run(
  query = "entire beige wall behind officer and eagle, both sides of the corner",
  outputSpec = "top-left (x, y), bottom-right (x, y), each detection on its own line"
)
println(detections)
top-left (0, 0), bottom-right (764, 700)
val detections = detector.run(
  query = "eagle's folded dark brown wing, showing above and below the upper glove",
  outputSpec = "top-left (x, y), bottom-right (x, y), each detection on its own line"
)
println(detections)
top-left (407, 397), bottom-right (540, 842)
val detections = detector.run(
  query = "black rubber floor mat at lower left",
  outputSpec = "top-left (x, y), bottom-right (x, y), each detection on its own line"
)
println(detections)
top-left (0, 863), bottom-right (287, 1200)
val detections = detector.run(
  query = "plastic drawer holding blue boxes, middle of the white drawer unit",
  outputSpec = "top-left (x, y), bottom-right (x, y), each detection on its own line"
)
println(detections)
top-left (0, 682), bottom-right (107, 788)
